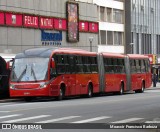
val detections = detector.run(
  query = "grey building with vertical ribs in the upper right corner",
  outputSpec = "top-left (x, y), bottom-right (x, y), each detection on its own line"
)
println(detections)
top-left (125, 0), bottom-right (160, 54)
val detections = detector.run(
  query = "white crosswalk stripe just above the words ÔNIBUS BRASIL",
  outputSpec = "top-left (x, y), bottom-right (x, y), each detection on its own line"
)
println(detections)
top-left (3, 115), bottom-right (50, 123)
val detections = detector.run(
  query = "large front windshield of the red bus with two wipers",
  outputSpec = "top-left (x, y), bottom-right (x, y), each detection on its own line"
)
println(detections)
top-left (11, 58), bottom-right (49, 82)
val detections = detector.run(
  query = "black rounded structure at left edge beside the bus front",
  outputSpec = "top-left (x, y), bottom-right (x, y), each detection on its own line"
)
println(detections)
top-left (0, 56), bottom-right (10, 98)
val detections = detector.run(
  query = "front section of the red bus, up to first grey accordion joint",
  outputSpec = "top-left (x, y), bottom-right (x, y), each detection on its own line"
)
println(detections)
top-left (10, 48), bottom-right (99, 100)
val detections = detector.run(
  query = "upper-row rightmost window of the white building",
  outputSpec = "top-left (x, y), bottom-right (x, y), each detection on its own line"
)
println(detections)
top-left (113, 9), bottom-right (123, 23)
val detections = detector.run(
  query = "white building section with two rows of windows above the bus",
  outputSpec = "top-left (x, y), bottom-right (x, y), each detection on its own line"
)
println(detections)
top-left (93, 0), bottom-right (125, 53)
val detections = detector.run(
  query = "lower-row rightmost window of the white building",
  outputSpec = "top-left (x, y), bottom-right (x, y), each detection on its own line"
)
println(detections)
top-left (114, 32), bottom-right (123, 45)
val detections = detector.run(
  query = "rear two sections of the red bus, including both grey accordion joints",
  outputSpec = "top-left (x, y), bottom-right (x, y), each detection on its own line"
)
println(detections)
top-left (98, 53), bottom-right (151, 94)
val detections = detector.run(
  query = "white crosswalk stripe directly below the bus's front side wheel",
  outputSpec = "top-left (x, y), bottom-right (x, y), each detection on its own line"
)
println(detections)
top-left (35, 116), bottom-right (80, 123)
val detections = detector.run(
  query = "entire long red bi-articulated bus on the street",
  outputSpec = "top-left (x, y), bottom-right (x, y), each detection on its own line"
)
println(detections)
top-left (10, 48), bottom-right (151, 101)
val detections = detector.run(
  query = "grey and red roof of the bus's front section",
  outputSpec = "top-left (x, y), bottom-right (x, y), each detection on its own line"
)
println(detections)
top-left (15, 47), bottom-right (97, 59)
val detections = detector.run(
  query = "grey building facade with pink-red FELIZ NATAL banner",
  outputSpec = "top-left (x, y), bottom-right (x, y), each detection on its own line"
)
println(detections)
top-left (0, 0), bottom-right (98, 54)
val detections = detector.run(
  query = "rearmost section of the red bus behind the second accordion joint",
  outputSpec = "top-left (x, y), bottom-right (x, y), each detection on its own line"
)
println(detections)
top-left (127, 54), bottom-right (152, 93)
